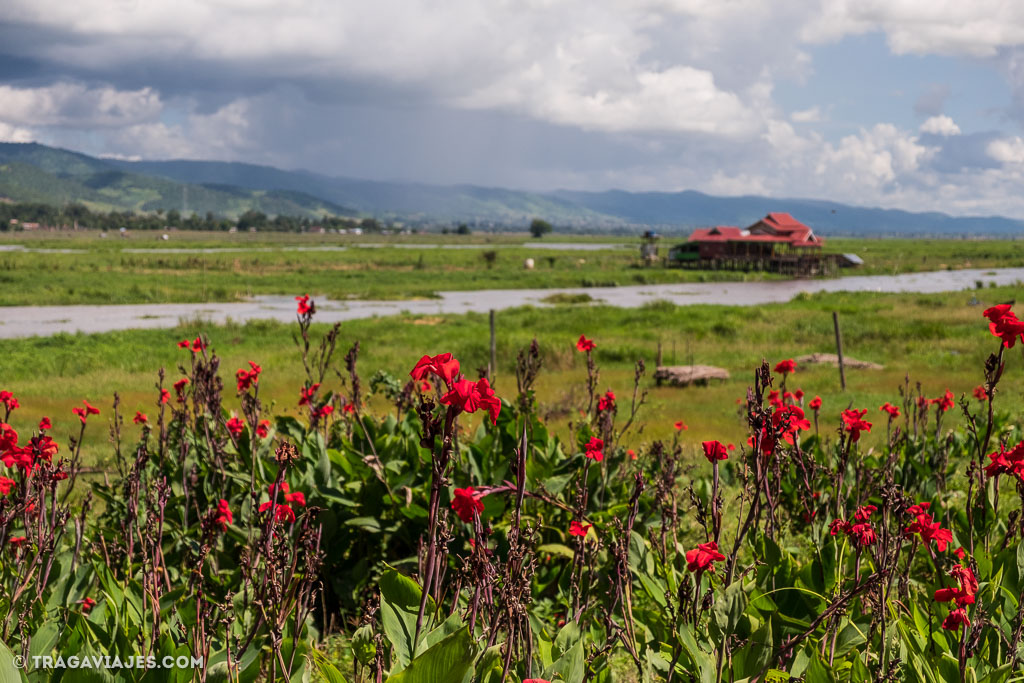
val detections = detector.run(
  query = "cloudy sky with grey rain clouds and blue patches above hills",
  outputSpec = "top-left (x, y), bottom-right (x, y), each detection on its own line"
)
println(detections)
top-left (0, 0), bottom-right (1024, 218)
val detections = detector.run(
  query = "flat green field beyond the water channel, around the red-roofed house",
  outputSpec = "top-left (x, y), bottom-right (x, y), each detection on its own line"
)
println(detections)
top-left (0, 231), bottom-right (1024, 305)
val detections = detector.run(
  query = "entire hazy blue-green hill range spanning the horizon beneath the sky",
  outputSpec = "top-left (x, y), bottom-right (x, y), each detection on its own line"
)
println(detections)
top-left (0, 143), bottom-right (1024, 237)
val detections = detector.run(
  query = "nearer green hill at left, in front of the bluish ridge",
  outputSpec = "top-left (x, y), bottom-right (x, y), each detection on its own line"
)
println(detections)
top-left (0, 143), bottom-right (357, 217)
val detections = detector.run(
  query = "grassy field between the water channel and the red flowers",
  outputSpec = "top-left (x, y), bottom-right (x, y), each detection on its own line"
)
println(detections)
top-left (0, 288), bottom-right (1024, 464)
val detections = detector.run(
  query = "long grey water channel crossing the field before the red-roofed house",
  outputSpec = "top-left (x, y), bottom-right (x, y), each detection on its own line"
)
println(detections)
top-left (0, 268), bottom-right (1024, 339)
